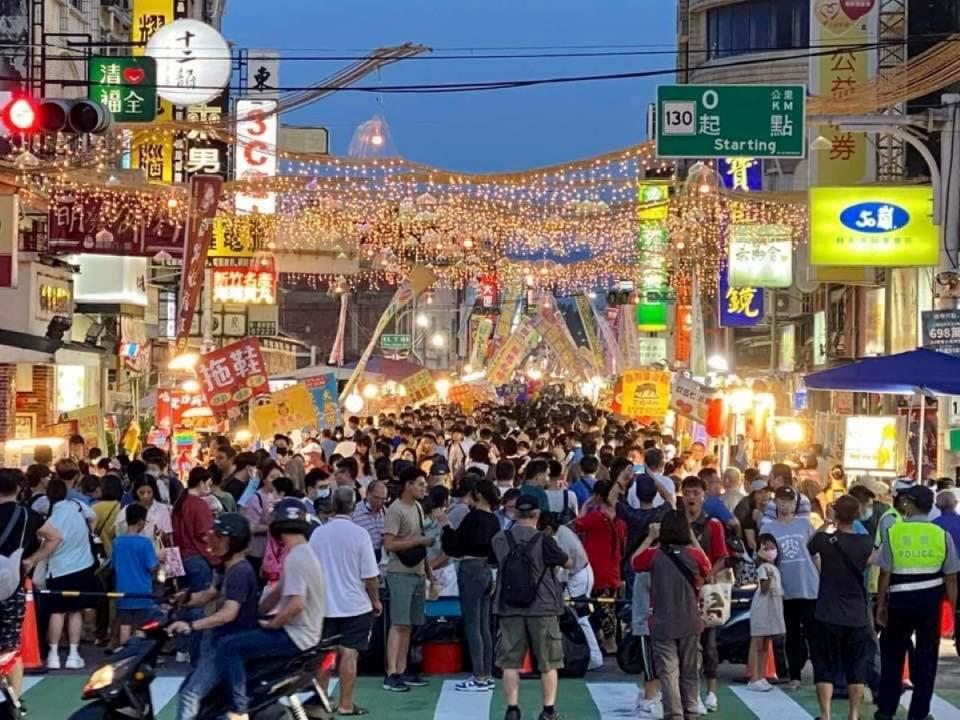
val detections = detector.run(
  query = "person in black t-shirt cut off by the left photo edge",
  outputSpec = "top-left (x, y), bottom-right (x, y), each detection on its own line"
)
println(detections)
top-left (0, 468), bottom-right (63, 695)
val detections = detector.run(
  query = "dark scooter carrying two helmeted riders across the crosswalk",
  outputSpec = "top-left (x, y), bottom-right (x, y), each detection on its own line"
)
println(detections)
top-left (68, 621), bottom-right (338, 720)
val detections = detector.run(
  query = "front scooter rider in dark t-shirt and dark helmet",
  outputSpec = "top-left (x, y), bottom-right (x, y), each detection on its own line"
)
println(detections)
top-left (168, 513), bottom-right (259, 720)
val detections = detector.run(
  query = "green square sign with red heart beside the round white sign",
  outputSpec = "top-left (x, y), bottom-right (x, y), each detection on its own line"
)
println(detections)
top-left (87, 55), bottom-right (157, 122)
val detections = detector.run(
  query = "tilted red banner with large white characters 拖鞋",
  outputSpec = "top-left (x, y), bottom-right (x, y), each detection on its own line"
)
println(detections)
top-left (197, 338), bottom-right (270, 418)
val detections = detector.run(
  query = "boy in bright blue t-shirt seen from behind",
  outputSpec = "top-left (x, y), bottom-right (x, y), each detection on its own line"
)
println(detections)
top-left (112, 503), bottom-right (159, 645)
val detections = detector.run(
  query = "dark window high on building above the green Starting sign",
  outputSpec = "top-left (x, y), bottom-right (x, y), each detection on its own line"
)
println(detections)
top-left (707, 0), bottom-right (810, 60)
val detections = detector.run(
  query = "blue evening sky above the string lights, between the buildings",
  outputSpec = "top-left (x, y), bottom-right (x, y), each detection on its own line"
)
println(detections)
top-left (224, 0), bottom-right (676, 172)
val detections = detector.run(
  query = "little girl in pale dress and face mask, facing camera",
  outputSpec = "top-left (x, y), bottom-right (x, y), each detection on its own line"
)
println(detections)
top-left (747, 533), bottom-right (787, 692)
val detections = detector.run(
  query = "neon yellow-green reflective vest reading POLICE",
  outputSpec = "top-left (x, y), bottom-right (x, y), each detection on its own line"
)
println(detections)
top-left (889, 522), bottom-right (947, 593)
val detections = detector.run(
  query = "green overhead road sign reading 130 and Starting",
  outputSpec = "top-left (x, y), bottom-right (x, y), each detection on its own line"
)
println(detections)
top-left (656, 85), bottom-right (806, 158)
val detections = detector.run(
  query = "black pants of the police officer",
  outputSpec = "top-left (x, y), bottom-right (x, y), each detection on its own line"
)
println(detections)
top-left (877, 605), bottom-right (940, 720)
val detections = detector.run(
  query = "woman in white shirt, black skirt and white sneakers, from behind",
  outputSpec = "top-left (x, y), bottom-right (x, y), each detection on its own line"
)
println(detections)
top-left (44, 477), bottom-right (100, 670)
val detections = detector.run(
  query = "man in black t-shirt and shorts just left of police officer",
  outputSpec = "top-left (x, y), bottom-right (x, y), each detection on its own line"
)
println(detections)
top-left (808, 495), bottom-right (874, 717)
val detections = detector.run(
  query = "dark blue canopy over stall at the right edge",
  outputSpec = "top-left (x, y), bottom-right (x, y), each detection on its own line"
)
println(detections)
top-left (804, 348), bottom-right (960, 395)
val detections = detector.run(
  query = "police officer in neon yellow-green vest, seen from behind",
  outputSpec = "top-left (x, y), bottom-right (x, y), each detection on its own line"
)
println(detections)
top-left (874, 486), bottom-right (960, 720)
